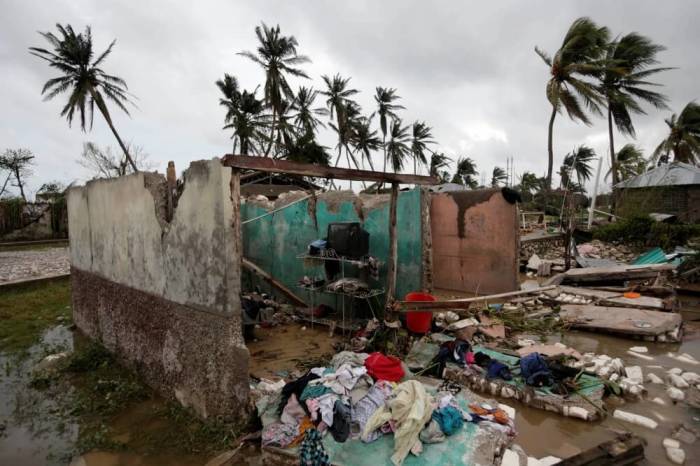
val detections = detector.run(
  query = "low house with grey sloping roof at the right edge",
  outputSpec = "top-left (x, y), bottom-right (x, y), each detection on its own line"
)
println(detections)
top-left (613, 162), bottom-right (700, 223)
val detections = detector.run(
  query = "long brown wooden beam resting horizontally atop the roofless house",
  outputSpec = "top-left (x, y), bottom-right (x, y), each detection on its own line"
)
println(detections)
top-left (221, 154), bottom-right (439, 185)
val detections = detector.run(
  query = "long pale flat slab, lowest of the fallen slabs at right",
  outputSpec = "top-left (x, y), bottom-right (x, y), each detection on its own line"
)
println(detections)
top-left (559, 304), bottom-right (682, 336)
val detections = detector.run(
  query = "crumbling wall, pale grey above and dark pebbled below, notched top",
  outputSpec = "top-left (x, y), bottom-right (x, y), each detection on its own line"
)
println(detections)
top-left (68, 159), bottom-right (249, 417)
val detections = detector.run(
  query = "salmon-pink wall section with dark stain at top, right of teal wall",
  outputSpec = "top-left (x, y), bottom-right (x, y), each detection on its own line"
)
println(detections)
top-left (430, 189), bottom-right (519, 294)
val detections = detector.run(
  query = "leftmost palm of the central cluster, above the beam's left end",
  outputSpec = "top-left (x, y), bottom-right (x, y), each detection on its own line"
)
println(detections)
top-left (217, 86), bottom-right (268, 155)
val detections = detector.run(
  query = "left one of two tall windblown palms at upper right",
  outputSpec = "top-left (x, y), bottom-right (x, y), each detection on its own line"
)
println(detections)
top-left (535, 18), bottom-right (610, 189)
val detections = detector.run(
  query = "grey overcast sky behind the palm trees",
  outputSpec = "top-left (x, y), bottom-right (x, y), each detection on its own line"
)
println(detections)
top-left (0, 0), bottom-right (700, 198)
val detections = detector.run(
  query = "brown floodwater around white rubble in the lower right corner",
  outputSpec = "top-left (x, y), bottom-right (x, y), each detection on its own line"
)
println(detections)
top-left (513, 322), bottom-right (700, 465)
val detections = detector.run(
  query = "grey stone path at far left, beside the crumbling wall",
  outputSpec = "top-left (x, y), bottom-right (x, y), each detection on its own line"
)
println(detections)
top-left (0, 247), bottom-right (70, 285)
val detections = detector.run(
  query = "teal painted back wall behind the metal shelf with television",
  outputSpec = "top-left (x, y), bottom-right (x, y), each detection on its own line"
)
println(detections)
top-left (241, 189), bottom-right (423, 305)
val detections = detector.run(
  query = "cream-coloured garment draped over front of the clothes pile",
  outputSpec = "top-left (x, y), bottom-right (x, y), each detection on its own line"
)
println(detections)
top-left (362, 380), bottom-right (433, 466)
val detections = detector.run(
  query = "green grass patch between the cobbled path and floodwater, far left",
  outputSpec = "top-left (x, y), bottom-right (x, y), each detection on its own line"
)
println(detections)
top-left (0, 278), bottom-right (71, 354)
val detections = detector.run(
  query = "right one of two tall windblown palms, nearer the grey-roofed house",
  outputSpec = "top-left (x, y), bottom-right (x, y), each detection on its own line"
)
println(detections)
top-left (600, 32), bottom-right (671, 185)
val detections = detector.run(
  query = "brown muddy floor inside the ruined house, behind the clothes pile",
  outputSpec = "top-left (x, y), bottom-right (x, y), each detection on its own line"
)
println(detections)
top-left (246, 323), bottom-right (341, 380)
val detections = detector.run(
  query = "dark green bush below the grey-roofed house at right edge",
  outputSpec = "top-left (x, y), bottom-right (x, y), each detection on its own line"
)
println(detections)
top-left (593, 215), bottom-right (700, 250)
